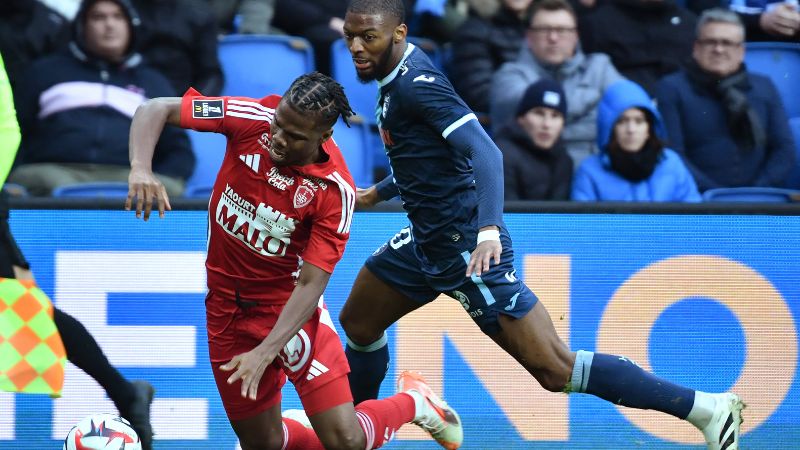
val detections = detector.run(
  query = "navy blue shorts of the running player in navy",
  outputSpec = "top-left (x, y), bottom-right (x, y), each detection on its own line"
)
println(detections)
top-left (365, 228), bottom-right (539, 335)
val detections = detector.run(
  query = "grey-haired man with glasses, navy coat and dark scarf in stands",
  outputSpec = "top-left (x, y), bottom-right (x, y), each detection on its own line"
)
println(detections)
top-left (656, 8), bottom-right (797, 191)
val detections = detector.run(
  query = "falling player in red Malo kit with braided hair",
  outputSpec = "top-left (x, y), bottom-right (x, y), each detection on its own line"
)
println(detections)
top-left (126, 72), bottom-right (463, 450)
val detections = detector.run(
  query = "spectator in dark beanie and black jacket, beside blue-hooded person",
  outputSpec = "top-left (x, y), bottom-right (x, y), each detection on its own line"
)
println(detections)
top-left (495, 79), bottom-right (573, 200)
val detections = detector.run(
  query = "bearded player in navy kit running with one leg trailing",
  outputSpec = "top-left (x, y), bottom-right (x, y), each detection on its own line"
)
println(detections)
top-left (340, 0), bottom-right (743, 450)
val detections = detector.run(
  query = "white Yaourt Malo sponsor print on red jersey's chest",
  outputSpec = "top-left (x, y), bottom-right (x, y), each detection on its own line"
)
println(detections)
top-left (215, 185), bottom-right (297, 256)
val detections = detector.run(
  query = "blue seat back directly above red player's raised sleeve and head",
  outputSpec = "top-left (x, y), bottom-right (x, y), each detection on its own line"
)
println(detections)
top-left (219, 35), bottom-right (314, 98)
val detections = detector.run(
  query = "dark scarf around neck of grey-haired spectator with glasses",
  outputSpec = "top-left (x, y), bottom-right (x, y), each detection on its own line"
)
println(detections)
top-left (687, 61), bottom-right (767, 150)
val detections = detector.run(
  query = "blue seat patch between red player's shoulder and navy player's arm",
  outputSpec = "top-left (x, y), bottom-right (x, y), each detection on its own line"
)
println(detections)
top-left (333, 119), bottom-right (374, 188)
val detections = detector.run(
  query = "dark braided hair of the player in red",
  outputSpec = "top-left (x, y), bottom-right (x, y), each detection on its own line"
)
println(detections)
top-left (283, 72), bottom-right (355, 127)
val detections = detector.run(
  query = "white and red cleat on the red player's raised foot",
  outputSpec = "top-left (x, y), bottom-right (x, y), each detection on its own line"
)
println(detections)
top-left (397, 371), bottom-right (464, 450)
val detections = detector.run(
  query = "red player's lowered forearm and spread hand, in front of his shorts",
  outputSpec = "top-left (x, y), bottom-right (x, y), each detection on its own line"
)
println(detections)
top-left (220, 262), bottom-right (331, 400)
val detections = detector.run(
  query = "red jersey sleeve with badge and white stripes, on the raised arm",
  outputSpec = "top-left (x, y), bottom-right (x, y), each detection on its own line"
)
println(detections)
top-left (181, 88), bottom-right (280, 149)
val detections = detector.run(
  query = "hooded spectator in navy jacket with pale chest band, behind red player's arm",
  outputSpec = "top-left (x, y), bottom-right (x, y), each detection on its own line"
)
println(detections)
top-left (9, 0), bottom-right (195, 196)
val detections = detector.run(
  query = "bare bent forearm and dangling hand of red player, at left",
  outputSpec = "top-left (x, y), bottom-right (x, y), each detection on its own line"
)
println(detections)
top-left (125, 97), bottom-right (181, 221)
